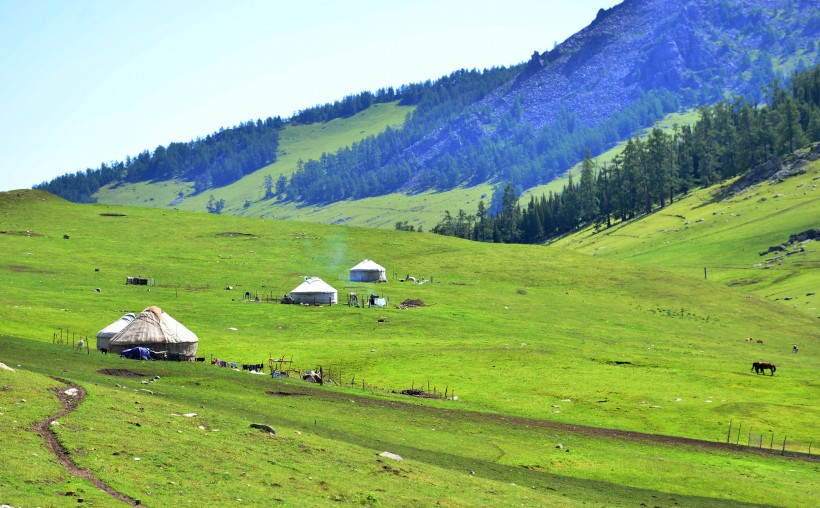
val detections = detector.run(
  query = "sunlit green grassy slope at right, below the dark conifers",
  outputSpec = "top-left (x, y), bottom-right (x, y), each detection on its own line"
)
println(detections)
top-left (555, 148), bottom-right (820, 322)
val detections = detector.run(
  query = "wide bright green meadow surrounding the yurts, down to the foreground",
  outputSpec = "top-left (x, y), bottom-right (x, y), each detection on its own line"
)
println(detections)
top-left (0, 185), bottom-right (820, 506)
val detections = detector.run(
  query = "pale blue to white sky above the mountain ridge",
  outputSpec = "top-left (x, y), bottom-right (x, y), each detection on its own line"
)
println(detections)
top-left (0, 0), bottom-right (619, 191)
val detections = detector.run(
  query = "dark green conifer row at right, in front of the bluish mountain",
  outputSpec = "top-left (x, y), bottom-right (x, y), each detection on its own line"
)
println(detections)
top-left (431, 66), bottom-right (820, 243)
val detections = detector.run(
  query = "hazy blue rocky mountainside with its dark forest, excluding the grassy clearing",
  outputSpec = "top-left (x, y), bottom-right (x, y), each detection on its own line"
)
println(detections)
top-left (37, 0), bottom-right (820, 212)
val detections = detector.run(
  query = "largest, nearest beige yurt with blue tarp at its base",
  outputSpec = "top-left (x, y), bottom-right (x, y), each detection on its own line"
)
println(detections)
top-left (108, 306), bottom-right (199, 361)
